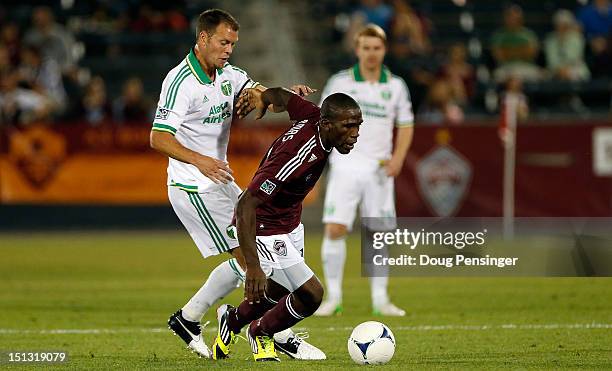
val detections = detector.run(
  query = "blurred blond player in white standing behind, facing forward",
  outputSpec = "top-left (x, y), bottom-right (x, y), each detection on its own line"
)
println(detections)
top-left (315, 25), bottom-right (414, 316)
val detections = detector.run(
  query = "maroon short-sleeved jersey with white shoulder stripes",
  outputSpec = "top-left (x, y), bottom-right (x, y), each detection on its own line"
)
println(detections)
top-left (248, 95), bottom-right (331, 236)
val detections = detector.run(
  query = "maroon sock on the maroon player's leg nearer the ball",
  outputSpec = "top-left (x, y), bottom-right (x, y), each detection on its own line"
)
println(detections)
top-left (249, 294), bottom-right (306, 336)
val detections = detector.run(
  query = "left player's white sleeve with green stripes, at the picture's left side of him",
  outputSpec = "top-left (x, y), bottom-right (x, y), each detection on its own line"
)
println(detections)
top-left (152, 69), bottom-right (191, 135)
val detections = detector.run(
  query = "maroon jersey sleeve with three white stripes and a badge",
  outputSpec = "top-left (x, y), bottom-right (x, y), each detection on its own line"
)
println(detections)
top-left (247, 135), bottom-right (316, 201)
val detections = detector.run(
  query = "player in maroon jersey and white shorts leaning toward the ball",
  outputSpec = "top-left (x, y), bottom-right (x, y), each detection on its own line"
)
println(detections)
top-left (213, 88), bottom-right (363, 361)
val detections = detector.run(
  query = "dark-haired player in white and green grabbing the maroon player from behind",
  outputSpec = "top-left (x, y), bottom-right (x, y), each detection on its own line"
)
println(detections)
top-left (151, 9), bottom-right (325, 359)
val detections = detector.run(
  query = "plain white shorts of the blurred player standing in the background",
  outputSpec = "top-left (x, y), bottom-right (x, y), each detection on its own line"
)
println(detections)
top-left (323, 165), bottom-right (396, 231)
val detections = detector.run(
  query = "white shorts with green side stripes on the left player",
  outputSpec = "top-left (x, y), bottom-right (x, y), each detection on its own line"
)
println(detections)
top-left (168, 182), bottom-right (242, 258)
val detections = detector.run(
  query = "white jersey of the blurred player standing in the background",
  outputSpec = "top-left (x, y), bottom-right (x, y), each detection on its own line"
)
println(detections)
top-left (321, 64), bottom-right (414, 170)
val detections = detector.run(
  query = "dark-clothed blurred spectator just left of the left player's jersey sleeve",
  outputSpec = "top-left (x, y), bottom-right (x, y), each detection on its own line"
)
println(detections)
top-left (113, 77), bottom-right (152, 124)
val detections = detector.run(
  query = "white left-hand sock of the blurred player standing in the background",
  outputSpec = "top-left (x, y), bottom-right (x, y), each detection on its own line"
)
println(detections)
top-left (321, 237), bottom-right (346, 303)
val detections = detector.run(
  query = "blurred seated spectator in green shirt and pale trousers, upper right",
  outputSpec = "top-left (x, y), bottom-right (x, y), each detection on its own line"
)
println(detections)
top-left (491, 5), bottom-right (541, 82)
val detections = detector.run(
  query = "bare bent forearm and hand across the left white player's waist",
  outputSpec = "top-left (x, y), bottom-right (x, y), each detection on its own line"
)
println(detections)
top-left (150, 130), bottom-right (233, 183)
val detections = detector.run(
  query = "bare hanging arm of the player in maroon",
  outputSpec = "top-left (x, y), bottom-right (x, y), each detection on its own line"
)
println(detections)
top-left (236, 189), bottom-right (266, 304)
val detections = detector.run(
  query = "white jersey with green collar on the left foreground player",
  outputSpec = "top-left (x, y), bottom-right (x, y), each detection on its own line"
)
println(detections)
top-left (152, 49), bottom-right (257, 192)
